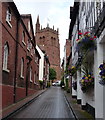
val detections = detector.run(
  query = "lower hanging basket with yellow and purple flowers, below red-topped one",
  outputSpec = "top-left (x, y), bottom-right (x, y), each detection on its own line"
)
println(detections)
top-left (80, 73), bottom-right (94, 92)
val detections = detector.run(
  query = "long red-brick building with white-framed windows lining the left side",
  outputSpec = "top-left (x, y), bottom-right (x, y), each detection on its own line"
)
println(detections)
top-left (0, 2), bottom-right (40, 108)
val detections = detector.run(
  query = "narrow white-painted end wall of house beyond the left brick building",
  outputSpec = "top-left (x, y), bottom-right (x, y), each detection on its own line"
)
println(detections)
top-left (36, 45), bottom-right (44, 81)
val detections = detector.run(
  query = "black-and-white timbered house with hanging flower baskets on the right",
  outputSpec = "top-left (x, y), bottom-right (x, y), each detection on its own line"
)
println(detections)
top-left (69, 0), bottom-right (105, 119)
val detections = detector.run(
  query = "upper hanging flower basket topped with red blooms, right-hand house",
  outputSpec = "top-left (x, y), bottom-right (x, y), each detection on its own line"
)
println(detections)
top-left (76, 32), bottom-right (96, 52)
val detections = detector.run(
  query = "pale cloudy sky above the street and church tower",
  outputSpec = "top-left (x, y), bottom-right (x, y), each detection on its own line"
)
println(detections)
top-left (14, 0), bottom-right (74, 61)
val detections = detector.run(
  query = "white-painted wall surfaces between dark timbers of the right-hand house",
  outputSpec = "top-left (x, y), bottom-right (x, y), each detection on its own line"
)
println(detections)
top-left (72, 0), bottom-right (105, 120)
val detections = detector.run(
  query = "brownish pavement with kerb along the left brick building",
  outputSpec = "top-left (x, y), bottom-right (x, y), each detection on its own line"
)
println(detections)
top-left (0, 88), bottom-right (47, 120)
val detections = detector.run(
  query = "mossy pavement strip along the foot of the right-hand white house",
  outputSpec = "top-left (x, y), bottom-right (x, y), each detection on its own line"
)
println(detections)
top-left (64, 91), bottom-right (95, 120)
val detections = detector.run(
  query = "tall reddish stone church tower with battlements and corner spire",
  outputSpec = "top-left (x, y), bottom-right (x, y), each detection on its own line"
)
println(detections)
top-left (35, 16), bottom-right (61, 80)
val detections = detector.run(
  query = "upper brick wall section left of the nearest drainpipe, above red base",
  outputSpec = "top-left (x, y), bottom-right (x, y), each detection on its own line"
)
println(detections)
top-left (2, 2), bottom-right (17, 85)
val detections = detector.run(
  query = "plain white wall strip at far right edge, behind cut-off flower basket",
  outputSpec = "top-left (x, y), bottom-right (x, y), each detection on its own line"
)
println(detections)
top-left (95, 33), bottom-right (105, 119)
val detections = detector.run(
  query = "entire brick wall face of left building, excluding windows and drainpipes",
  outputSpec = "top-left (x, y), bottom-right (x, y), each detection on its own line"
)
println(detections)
top-left (2, 2), bottom-right (39, 108)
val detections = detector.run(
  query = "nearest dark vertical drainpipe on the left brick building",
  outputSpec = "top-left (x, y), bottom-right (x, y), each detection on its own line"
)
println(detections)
top-left (13, 18), bottom-right (19, 103)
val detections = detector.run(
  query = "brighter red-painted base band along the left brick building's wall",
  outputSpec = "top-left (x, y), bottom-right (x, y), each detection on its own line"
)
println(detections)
top-left (0, 85), bottom-right (38, 108)
